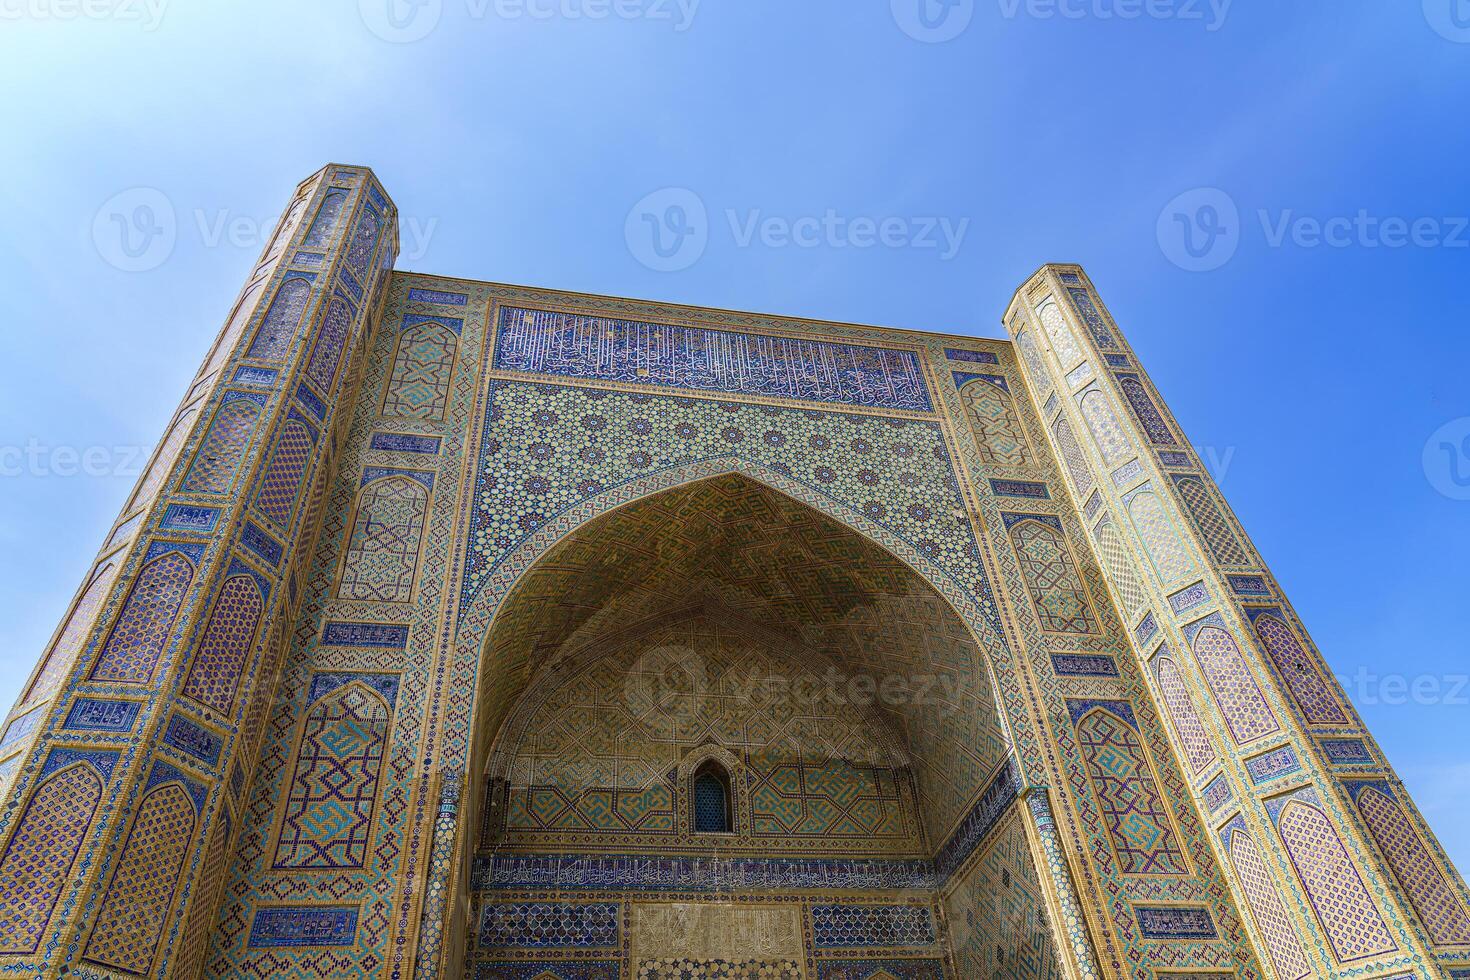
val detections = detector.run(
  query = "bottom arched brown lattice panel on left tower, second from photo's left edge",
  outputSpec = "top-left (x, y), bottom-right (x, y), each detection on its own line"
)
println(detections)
top-left (87, 782), bottom-right (198, 974)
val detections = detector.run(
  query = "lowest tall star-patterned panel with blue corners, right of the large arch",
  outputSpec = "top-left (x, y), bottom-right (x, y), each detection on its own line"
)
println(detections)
top-left (1069, 702), bottom-right (1189, 874)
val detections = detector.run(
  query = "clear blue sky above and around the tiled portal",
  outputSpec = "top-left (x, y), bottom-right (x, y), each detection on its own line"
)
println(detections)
top-left (0, 0), bottom-right (1470, 868)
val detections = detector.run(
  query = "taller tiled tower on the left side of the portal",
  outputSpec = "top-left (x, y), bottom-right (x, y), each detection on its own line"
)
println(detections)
top-left (0, 166), bottom-right (397, 977)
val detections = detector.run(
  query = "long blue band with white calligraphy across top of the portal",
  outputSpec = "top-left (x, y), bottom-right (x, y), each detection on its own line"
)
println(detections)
top-left (494, 306), bottom-right (932, 411)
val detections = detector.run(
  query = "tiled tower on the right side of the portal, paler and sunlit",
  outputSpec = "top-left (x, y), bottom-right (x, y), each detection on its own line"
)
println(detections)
top-left (1005, 266), bottom-right (1470, 980)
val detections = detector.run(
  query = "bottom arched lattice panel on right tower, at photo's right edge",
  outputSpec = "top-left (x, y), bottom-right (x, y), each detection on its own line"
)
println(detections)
top-left (1347, 782), bottom-right (1470, 946)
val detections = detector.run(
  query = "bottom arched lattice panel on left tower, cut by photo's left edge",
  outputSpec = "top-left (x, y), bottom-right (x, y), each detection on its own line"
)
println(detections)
top-left (0, 763), bottom-right (103, 954)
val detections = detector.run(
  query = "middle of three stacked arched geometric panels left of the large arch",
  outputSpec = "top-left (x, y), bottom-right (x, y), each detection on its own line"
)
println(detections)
top-left (338, 476), bottom-right (429, 602)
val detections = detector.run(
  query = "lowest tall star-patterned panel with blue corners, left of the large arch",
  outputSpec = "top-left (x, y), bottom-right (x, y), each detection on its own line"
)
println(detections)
top-left (272, 674), bottom-right (398, 868)
